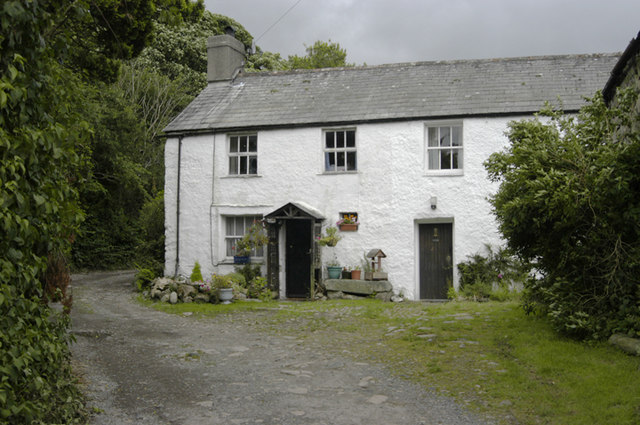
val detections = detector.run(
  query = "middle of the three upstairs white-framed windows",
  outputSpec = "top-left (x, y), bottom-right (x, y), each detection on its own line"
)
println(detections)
top-left (322, 128), bottom-right (358, 174)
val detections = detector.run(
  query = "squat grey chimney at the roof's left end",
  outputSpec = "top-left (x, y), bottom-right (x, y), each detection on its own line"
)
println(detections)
top-left (207, 34), bottom-right (244, 83)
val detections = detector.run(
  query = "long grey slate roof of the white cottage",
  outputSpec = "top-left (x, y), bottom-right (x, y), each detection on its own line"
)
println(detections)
top-left (165, 53), bottom-right (620, 134)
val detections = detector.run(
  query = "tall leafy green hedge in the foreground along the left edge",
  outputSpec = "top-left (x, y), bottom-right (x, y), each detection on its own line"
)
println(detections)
top-left (0, 0), bottom-right (88, 423)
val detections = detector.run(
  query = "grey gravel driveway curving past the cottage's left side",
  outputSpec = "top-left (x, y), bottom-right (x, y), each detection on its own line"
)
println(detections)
top-left (71, 272), bottom-right (484, 425)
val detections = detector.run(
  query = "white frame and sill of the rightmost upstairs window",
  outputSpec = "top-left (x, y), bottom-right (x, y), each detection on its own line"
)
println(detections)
top-left (424, 121), bottom-right (465, 176)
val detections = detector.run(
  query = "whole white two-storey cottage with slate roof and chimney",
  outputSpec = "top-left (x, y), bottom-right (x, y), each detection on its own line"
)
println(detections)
top-left (165, 35), bottom-right (618, 300)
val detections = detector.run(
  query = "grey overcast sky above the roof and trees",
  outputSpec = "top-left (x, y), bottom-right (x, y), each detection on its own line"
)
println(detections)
top-left (205, 0), bottom-right (640, 65)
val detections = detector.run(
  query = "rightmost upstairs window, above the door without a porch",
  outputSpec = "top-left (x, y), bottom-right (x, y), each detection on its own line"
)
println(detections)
top-left (427, 125), bottom-right (462, 171)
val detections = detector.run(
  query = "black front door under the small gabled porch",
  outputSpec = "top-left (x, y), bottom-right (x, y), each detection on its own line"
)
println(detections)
top-left (285, 219), bottom-right (313, 298)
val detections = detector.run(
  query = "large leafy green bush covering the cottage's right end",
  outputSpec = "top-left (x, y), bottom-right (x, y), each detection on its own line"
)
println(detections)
top-left (486, 91), bottom-right (640, 338)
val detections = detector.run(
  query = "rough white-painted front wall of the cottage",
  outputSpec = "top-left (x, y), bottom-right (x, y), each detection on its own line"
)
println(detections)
top-left (165, 114), bottom-right (524, 298)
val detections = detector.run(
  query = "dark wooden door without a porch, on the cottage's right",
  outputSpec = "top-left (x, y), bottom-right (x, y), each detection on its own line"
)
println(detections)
top-left (420, 223), bottom-right (453, 300)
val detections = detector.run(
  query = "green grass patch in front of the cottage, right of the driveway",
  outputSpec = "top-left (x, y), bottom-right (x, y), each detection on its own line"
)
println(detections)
top-left (136, 300), bottom-right (640, 425)
